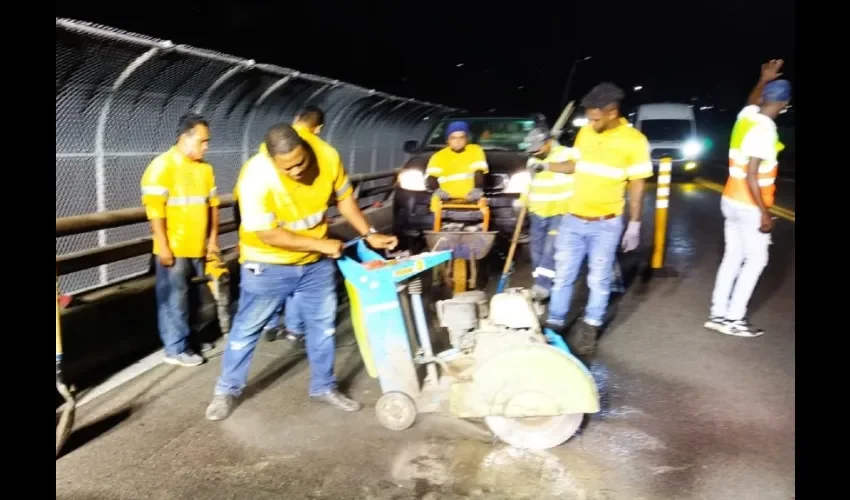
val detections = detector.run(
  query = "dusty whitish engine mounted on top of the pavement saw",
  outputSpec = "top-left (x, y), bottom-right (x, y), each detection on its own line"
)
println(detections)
top-left (436, 289), bottom-right (545, 356)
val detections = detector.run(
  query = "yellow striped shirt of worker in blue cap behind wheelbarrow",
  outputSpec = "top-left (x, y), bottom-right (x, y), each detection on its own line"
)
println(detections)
top-left (425, 144), bottom-right (489, 210)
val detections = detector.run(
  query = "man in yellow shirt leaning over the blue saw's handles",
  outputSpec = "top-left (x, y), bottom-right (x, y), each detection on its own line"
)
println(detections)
top-left (206, 124), bottom-right (398, 420)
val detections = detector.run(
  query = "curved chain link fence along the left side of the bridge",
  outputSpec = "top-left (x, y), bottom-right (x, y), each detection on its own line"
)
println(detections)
top-left (56, 18), bottom-right (455, 293)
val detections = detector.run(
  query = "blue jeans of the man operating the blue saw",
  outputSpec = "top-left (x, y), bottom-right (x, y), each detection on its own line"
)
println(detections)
top-left (215, 259), bottom-right (337, 396)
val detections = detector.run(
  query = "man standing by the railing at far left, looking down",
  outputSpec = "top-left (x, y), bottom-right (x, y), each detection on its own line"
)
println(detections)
top-left (141, 114), bottom-right (219, 366)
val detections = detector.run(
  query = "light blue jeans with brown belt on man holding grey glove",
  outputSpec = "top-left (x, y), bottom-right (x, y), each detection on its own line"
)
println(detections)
top-left (548, 215), bottom-right (623, 326)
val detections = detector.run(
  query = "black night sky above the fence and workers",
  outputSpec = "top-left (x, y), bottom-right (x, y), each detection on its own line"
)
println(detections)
top-left (56, 0), bottom-right (795, 124)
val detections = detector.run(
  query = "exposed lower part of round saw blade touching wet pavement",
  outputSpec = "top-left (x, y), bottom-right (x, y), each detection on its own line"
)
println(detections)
top-left (484, 413), bottom-right (584, 450)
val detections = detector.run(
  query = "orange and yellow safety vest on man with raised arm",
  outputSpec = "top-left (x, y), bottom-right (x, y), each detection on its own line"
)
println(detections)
top-left (723, 106), bottom-right (785, 207)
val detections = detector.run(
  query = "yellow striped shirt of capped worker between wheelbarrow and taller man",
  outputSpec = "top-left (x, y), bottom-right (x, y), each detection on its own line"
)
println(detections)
top-left (520, 142), bottom-right (575, 217)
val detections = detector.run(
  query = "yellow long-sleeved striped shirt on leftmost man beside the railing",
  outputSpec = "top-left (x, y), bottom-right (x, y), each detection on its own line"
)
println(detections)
top-left (141, 147), bottom-right (220, 258)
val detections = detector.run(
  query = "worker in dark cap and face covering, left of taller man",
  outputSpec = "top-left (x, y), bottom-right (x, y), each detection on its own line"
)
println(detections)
top-left (519, 128), bottom-right (573, 300)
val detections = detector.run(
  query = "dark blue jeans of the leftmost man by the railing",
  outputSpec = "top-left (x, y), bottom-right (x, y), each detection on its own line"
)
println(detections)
top-left (154, 256), bottom-right (204, 356)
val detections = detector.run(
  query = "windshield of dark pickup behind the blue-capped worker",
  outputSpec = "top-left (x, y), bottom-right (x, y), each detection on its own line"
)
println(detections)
top-left (425, 118), bottom-right (534, 151)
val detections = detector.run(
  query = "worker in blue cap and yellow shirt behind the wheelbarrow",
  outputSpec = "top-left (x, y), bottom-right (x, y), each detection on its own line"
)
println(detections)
top-left (425, 121), bottom-right (488, 207)
